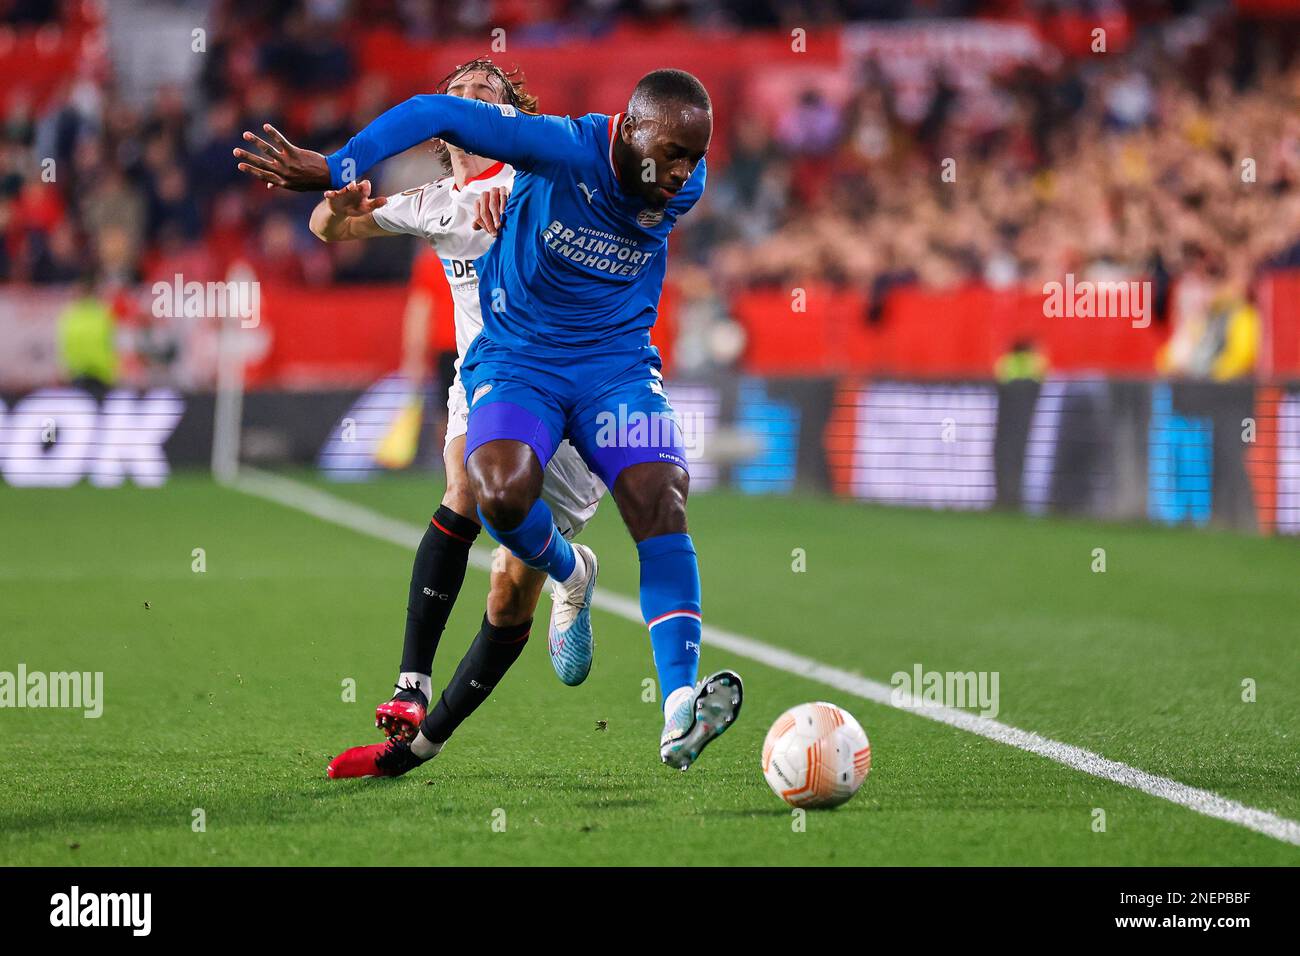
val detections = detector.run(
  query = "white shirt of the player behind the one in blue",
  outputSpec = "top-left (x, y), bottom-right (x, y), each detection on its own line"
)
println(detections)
top-left (373, 163), bottom-right (515, 373)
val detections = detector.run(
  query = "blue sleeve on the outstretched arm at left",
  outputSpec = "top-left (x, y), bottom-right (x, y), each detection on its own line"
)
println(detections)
top-left (325, 94), bottom-right (581, 189)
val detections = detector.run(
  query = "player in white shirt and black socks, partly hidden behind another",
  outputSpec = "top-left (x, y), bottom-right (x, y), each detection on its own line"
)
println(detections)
top-left (301, 60), bottom-right (606, 778)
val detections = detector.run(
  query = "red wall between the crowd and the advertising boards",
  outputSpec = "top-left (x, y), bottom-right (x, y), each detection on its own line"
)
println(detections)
top-left (10, 271), bottom-right (1300, 390)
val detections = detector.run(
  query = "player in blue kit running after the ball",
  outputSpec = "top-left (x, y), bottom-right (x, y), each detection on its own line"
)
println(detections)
top-left (237, 69), bottom-right (742, 775)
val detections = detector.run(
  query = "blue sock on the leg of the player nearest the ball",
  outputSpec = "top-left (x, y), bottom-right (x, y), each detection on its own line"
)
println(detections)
top-left (637, 535), bottom-right (702, 700)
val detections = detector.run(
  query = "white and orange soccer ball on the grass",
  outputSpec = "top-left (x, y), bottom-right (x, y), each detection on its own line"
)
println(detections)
top-left (763, 701), bottom-right (871, 806)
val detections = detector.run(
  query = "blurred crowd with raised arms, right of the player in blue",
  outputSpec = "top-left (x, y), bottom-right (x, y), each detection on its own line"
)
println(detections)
top-left (686, 41), bottom-right (1300, 306)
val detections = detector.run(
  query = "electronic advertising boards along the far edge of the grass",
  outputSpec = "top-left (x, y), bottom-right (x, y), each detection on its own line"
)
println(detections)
top-left (0, 375), bottom-right (1300, 535)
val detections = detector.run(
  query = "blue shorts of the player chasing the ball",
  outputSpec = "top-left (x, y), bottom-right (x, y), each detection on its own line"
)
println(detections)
top-left (460, 336), bottom-right (688, 489)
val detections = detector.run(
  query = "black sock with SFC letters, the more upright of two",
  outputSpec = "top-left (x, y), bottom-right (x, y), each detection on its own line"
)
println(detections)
top-left (402, 506), bottom-right (478, 674)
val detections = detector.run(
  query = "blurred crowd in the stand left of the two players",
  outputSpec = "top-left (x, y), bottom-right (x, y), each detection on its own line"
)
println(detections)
top-left (0, 22), bottom-right (406, 285)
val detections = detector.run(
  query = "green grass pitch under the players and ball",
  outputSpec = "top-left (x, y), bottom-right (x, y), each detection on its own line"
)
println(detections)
top-left (0, 475), bottom-right (1300, 865)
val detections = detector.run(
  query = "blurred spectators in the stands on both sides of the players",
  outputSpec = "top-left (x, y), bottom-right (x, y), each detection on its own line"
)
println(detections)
top-left (0, 0), bottom-right (1284, 382)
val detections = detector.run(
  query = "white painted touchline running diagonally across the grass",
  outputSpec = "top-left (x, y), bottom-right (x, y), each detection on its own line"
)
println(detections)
top-left (231, 468), bottom-right (1300, 847)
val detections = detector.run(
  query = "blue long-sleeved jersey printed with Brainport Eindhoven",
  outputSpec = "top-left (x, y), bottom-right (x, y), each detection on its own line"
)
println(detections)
top-left (326, 95), bottom-right (705, 358)
